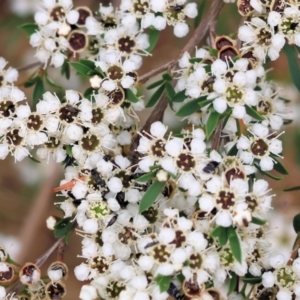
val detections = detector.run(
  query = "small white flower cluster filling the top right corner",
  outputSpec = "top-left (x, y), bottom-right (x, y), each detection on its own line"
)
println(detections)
top-left (238, 0), bottom-right (300, 61)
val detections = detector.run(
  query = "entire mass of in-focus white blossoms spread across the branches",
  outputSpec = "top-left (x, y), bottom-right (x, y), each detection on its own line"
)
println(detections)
top-left (0, 0), bottom-right (300, 300)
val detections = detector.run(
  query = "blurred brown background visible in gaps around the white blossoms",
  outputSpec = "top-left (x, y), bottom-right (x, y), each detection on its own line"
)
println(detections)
top-left (0, 0), bottom-right (300, 300)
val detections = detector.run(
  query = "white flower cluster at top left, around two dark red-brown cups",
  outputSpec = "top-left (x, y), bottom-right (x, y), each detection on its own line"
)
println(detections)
top-left (30, 0), bottom-right (198, 68)
